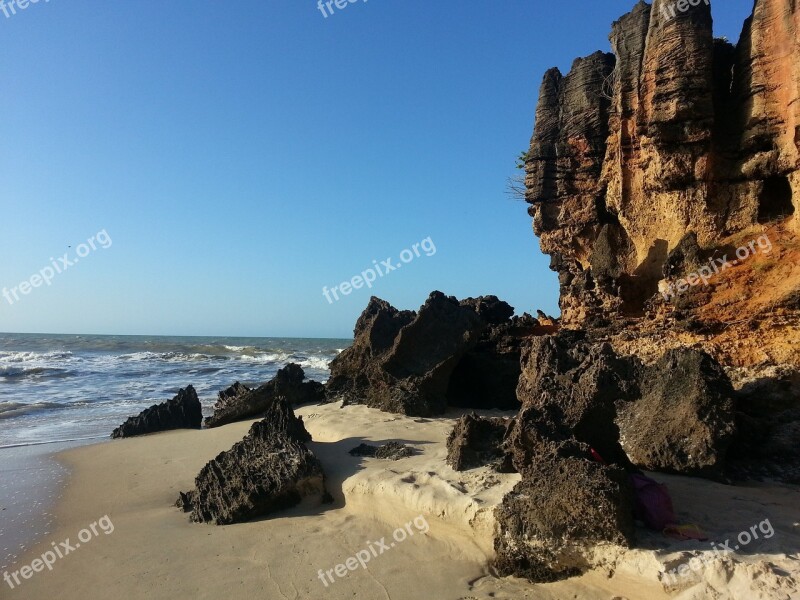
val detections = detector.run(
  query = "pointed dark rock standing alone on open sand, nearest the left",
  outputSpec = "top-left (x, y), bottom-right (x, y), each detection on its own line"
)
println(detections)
top-left (176, 397), bottom-right (329, 525)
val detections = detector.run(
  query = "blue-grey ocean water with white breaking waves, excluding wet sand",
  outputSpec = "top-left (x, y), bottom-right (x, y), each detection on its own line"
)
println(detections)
top-left (0, 333), bottom-right (352, 448)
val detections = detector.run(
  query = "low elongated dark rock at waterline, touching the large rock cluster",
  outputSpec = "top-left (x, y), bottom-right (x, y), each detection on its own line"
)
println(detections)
top-left (206, 363), bottom-right (325, 427)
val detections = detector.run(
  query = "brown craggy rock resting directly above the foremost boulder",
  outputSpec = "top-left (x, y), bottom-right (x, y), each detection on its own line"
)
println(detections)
top-left (515, 331), bottom-right (641, 469)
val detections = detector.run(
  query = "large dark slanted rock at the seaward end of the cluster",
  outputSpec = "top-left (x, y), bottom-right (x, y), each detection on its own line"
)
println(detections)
top-left (327, 292), bottom-right (486, 417)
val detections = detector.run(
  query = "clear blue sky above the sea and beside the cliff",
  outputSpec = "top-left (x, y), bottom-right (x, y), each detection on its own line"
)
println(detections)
top-left (0, 0), bottom-right (752, 337)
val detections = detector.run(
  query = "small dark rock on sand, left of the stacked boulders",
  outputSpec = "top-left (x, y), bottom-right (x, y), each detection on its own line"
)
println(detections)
top-left (447, 414), bottom-right (514, 473)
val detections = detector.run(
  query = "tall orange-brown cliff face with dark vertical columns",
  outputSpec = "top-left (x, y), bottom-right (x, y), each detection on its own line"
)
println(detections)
top-left (526, 0), bottom-right (800, 365)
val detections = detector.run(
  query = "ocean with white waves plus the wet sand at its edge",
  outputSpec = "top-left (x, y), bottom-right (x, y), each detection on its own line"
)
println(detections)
top-left (0, 333), bottom-right (352, 571)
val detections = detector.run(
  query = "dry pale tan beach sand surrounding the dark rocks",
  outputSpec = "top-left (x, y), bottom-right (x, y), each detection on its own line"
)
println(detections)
top-left (6, 405), bottom-right (800, 600)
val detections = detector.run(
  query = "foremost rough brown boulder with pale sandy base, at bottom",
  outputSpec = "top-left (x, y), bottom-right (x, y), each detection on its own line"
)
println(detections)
top-left (493, 438), bottom-right (634, 582)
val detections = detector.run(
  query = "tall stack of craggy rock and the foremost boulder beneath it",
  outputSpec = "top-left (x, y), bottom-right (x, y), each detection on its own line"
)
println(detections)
top-left (495, 331), bottom-right (641, 581)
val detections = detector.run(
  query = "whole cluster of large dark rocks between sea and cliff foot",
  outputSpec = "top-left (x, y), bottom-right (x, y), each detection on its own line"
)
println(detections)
top-left (326, 292), bottom-right (541, 417)
